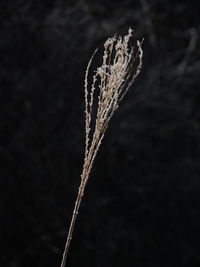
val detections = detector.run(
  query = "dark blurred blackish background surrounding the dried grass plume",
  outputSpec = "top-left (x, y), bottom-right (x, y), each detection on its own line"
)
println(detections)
top-left (0, 0), bottom-right (200, 267)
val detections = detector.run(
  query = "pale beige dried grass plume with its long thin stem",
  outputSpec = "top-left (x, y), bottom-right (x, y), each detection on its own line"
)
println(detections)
top-left (60, 29), bottom-right (143, 267)
